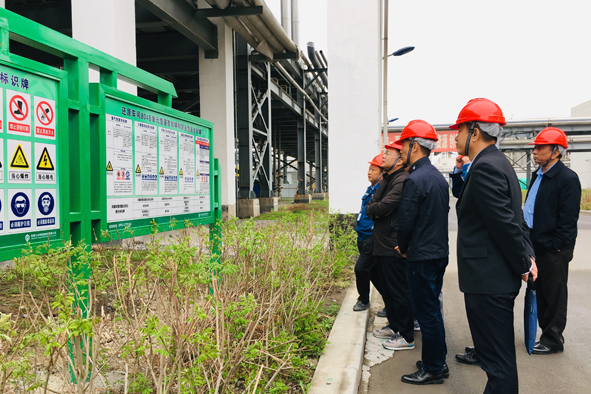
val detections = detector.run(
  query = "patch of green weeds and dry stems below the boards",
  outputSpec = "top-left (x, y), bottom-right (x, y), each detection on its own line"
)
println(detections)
top-left (0, 208), bottom-right (355, 394)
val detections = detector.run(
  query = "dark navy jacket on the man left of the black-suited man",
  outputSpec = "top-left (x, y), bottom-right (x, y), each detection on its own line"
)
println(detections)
top-left (397, 157), bottom-right (449, 261)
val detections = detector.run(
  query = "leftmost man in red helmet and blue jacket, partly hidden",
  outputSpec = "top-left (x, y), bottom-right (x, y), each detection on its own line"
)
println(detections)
top-left (353, 153), bottom-right (384, 312)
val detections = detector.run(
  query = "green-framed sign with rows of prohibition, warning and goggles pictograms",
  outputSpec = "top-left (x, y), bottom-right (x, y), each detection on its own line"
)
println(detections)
top-left (0, 65), bottom-right (60, 240)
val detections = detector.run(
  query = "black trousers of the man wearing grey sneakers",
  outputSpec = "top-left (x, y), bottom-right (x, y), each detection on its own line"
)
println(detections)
top-left (375, 256), bottom-right (414, 343)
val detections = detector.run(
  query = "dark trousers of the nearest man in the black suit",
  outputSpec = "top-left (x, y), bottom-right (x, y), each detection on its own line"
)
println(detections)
top-left (464, 292), bottom-right (519, 394)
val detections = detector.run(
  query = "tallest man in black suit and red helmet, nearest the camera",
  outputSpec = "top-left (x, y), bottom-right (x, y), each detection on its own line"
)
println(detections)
top-left (450, 99), bottom-right (537, 394)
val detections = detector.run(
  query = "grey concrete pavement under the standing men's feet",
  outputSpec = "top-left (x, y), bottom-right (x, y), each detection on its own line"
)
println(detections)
top-left (359, 208), bottom-right (591, 394)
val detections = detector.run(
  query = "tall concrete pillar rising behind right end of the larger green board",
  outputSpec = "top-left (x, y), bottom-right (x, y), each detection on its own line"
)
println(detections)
top-left (199, 14), bottom-right (236, 220)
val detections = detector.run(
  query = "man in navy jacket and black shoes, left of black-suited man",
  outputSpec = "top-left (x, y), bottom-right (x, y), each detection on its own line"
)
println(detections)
top-left (397, 120), bottom-right (449, 385)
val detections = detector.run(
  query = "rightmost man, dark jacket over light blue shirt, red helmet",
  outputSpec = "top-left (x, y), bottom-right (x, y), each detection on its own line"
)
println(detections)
top-left (523, 127), bottom-right (581, 354)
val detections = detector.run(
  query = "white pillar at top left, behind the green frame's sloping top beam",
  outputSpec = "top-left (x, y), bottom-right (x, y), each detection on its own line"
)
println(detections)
top-left (72, 0), bottom-right (137, 94)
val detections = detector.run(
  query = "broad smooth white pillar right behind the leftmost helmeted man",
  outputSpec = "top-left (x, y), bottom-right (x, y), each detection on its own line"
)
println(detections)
top-left (327, 0), bottom-right (382, 213)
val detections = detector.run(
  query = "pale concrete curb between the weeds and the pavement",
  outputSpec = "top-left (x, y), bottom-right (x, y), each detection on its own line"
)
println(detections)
top-left (308, 280), bottom-right (369, 394)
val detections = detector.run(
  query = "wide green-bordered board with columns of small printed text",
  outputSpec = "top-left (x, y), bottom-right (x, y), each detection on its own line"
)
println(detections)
top-left (104, 97), bottom-right (213, 230)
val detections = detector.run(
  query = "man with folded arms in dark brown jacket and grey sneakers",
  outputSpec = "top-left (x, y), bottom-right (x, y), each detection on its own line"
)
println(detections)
top-left (366, 143), bottom-right (415, 350)
